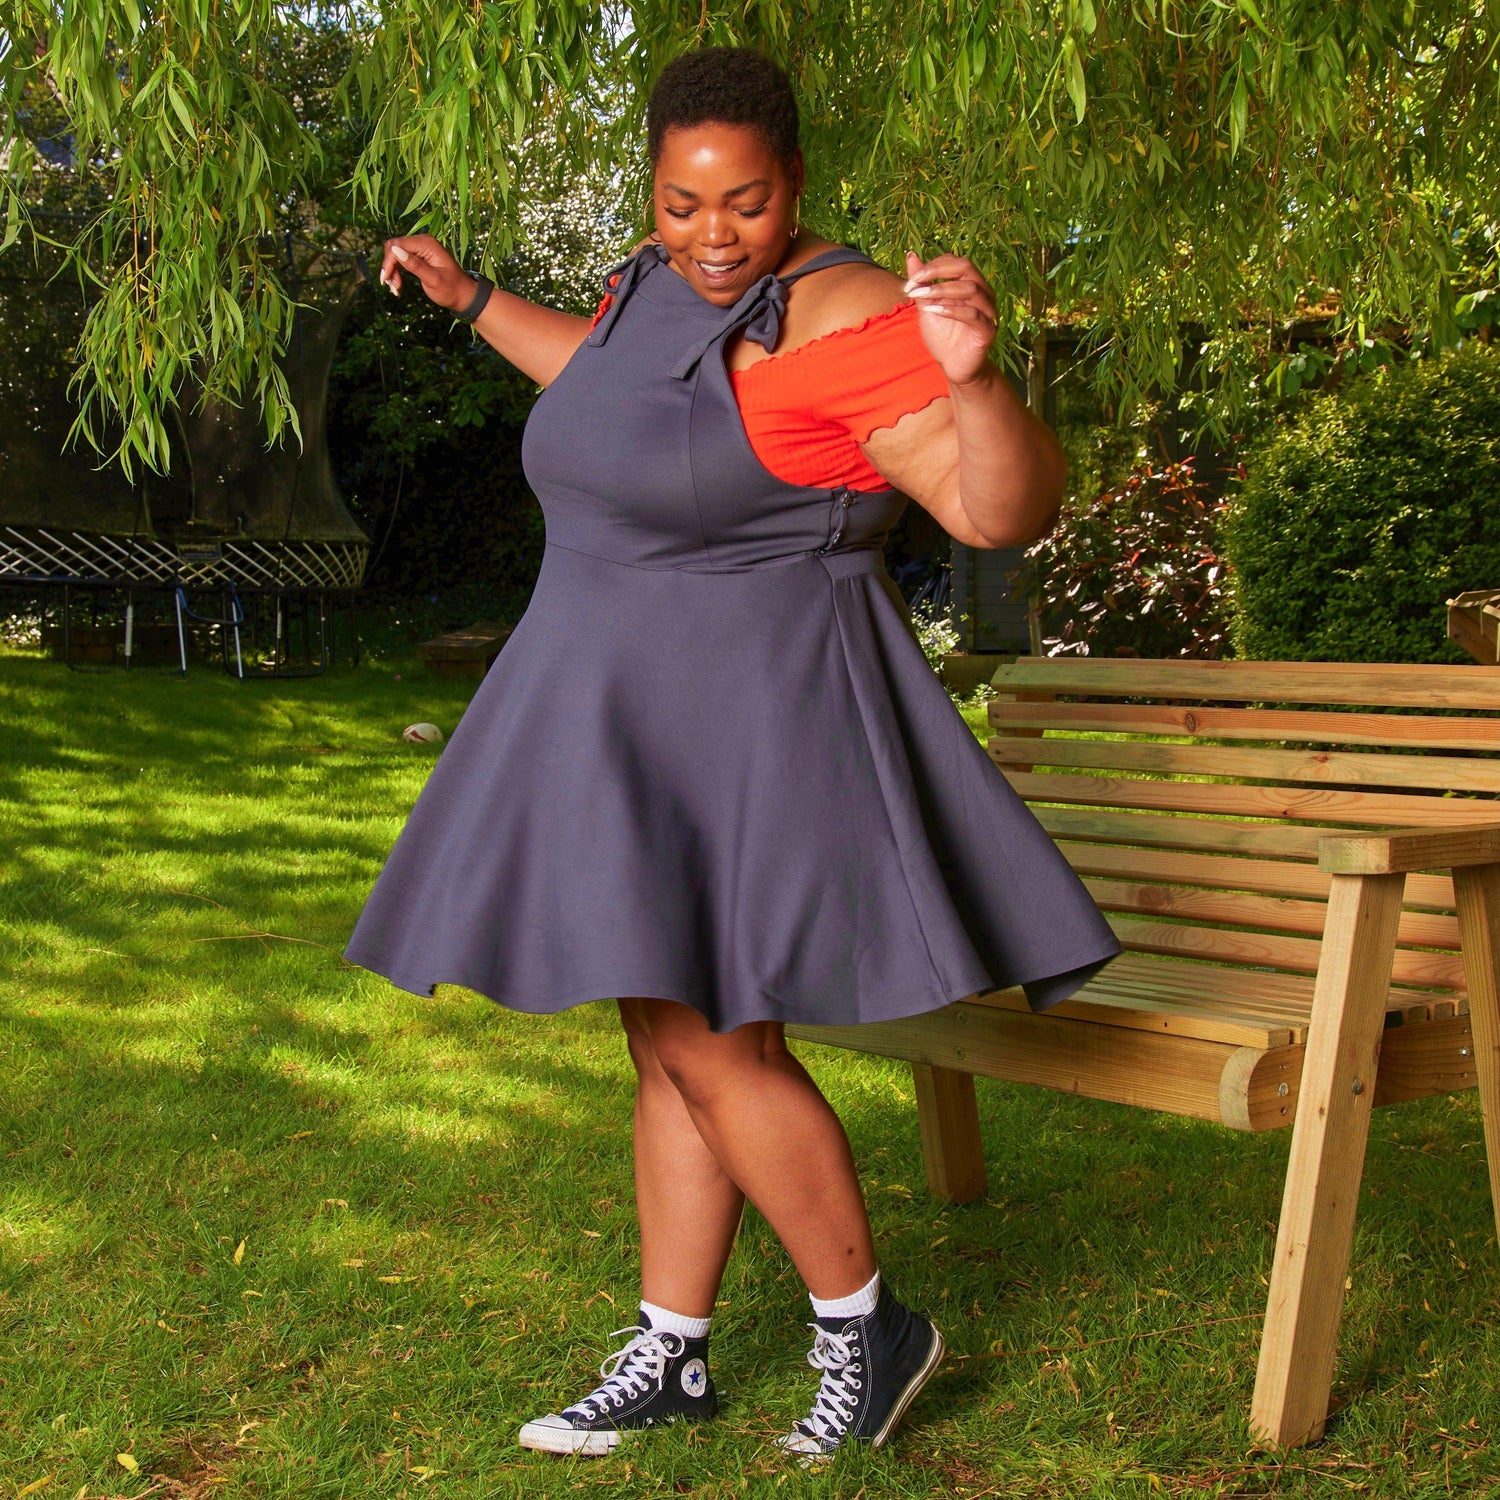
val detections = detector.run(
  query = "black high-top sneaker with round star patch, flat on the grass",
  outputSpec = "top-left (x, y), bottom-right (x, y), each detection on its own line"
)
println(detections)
top-left (521, 1313), bottom-right (719, 1458)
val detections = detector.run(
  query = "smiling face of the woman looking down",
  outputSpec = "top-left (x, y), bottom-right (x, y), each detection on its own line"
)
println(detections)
top-left (653, 125), bottom-right (803, 308)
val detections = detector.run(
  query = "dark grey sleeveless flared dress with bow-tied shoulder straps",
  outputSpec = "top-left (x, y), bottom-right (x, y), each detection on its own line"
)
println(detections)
top-left (345, 246), bottom-right (1119, 1032)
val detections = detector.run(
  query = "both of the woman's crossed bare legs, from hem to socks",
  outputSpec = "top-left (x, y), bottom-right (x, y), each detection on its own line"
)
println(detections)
top-left (621, 999), bottom-right (876, 1316)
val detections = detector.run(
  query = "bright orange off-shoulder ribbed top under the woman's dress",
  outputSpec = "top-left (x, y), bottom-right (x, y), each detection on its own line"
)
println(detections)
top-left (594, 297), bottom-right (948, 492)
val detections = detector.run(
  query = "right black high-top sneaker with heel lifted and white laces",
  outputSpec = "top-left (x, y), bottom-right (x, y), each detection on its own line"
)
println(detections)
top-left (777, 1283), bottom-right (944, 1466)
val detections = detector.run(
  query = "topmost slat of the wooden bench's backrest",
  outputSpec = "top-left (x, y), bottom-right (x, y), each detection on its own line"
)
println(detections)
top-left (995, 657), bottom-right (1500, 713)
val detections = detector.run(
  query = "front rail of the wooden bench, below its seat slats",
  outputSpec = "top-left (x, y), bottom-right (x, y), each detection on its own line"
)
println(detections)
top-left (786, 1002), bottom-right (1235, 1121)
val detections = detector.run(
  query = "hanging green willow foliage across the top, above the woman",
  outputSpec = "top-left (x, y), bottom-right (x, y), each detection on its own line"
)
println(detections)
top-left (0, 0), bottom-right (1500, 464)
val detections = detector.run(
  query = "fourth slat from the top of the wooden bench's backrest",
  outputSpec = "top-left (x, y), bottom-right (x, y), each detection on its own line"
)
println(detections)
top-left (992, 774), bottom-right (1482, 828)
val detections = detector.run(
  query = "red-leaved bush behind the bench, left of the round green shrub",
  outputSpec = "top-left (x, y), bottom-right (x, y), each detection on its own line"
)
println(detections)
top-left (1026, 459), bottom-right (1229, 659)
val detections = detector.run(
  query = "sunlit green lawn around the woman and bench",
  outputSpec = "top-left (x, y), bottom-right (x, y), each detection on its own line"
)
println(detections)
top-left (0, 653), bottom-right (1500, 1500)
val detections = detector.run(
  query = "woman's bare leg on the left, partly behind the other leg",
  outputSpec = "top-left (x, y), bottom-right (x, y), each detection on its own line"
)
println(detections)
top-left (620, 999), bottom-right (746, 1317)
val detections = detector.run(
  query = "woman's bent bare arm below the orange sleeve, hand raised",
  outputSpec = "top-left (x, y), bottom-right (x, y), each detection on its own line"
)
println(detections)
top-left (864, 255), bottom-right (1067, 548)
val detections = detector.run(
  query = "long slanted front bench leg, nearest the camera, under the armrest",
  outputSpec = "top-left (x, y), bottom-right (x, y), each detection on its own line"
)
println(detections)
top-left (1250, 875), bottom-right (1406, 1448)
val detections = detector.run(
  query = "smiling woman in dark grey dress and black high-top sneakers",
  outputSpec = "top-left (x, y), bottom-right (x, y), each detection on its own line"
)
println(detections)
top-left (348, 48), bottom-right (1118, 1461)
